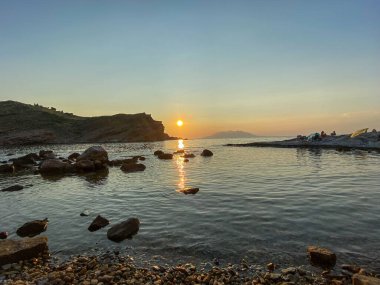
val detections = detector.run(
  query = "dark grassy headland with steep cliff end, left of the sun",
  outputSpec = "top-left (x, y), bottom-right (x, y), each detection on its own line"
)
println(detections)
top-left (0, 101), bottom-right (174, 145)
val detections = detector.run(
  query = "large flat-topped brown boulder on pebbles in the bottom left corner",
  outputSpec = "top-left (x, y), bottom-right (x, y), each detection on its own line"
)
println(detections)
top-left (0, 234), bottom-right (48, 266)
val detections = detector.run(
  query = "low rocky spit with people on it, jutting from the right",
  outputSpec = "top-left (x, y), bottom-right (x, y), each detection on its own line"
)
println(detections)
top-left (227, 132), bottom-right (380, 151)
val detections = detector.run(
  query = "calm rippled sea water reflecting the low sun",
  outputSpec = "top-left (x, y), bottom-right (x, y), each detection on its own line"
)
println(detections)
top-left (0, 138), bottom-right (380, 270)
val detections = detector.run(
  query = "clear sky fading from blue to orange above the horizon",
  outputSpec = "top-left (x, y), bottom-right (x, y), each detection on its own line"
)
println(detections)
top-left (0, 0), bottom-right (380, 138)
